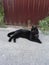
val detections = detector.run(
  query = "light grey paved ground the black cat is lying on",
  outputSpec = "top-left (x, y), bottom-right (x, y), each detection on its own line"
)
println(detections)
top-left (0, 28), bottom-right (49, 65)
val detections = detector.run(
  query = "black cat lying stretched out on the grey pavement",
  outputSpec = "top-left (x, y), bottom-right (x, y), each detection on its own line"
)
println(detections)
top-left (8, 26), bottom-right (41, 43)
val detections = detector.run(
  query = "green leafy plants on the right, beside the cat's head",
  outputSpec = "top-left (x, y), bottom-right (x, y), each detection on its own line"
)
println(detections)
top-left (39, 16), bottom-right (49, 34)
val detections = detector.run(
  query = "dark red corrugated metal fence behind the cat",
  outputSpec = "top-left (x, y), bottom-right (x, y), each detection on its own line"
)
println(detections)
top-left (3, 0), bottom-right (49, 24)
